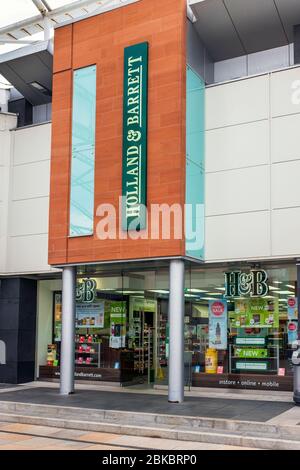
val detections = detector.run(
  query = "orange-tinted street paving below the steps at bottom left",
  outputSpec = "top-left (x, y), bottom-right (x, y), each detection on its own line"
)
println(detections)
top-left (0, 422), bottom-right (254, 451)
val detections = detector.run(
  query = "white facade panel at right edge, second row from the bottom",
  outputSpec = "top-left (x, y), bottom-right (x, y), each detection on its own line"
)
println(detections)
top-left (272, 160), bottom-right (300, 209)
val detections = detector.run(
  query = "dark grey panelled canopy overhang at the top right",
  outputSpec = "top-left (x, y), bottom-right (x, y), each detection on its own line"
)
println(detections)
top-left (189, 0), bottom-right (300, 61)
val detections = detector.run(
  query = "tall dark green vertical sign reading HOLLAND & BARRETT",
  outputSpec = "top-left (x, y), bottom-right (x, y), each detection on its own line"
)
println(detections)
top-left (122, 42), bottom-right (148, 231)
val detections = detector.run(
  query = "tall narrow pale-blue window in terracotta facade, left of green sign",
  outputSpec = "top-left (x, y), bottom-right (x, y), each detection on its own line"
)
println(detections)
top-left (70, 65), bottom-right (96, 236)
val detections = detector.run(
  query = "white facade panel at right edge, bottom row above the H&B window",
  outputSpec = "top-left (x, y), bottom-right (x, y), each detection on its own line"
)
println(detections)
top-left (272, 207), bottom-right (300, 257)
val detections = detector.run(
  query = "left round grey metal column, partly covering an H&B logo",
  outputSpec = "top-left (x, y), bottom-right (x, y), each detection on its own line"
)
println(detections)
top-left (60, 266), bottom-right (76, 395)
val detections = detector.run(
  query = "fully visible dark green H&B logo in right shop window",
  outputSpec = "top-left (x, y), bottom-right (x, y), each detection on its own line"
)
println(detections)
top-left (225, 269), bottom-right (269, 297)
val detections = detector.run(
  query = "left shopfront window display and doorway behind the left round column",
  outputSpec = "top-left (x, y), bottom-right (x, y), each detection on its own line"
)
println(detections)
top-left (39, 278), bottom-right (162, 384)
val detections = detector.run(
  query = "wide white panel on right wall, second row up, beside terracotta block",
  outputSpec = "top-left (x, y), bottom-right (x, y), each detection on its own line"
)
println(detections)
top-left (206, 165), bottom-right (270, 216)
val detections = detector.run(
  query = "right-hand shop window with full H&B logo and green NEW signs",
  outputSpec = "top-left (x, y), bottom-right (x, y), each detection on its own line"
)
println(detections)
top-left (188, 265), bottom-right (298, 389)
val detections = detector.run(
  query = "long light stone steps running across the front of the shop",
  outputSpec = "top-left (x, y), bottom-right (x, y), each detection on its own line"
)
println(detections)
top-left (0, 402), bottom-right (300, 450)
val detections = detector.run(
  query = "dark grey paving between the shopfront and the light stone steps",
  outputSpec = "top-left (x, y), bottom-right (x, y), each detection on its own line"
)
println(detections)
top-left (0, 387), bottom-right (294, 422)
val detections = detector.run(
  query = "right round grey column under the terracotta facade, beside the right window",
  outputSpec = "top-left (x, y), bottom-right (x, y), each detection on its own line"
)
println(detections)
top-left (169, 260), bottom-right (185, 403)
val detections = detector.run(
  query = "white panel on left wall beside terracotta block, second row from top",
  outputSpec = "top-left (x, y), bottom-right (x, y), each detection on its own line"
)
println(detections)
top-left (12, 160), bottom-right (50, 201)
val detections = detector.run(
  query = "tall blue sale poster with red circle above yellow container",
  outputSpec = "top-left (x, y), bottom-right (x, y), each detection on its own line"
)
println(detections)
top-left (208, 300), bottom-right (227, 350)
